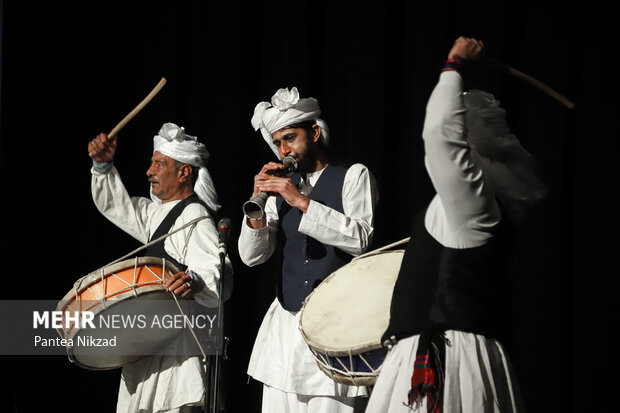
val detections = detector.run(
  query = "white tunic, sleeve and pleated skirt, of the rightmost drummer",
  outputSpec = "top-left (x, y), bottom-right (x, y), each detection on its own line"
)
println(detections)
top-left (366, 71), bottom-right (522, 413)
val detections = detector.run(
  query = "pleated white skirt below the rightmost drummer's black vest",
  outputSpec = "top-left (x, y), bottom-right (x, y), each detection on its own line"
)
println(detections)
top-left (366, 330), bottom-right (525, 413)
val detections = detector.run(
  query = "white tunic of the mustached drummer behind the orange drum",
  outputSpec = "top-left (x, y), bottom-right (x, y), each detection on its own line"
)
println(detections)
top-left (91, 167), bottom-right (232, 413)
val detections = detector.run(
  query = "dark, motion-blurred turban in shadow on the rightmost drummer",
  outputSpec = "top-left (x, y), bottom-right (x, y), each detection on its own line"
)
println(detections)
top-left (464, 90), bottom-right (547, 219)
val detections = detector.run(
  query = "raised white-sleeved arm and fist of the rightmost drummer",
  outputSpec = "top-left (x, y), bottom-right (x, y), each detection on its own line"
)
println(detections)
top-left (423, 38), bottom-right (499, 247)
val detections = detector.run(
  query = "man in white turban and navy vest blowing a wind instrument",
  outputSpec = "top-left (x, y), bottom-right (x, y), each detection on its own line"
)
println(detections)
top-left (238, 88), bottom-right (378, 413)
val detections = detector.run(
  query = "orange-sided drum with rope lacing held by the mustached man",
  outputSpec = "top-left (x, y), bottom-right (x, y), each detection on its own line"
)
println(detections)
top-left (56, 257), bottom-right (180, 370)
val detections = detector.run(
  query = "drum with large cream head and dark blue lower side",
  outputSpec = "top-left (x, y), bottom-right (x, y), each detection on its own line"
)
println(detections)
top-left (299, 245), bottom-right (404, 386)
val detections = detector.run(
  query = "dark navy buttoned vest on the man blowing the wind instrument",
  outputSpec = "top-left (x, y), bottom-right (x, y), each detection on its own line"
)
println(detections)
top-left (276, 164), bottom-right (352, 311)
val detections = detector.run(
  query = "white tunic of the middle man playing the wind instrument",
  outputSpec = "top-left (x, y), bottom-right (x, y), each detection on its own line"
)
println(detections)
top-left (238, 164), bottom-right (378, 397)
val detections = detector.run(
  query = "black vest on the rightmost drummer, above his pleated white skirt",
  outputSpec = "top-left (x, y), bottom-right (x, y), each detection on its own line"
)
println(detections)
top-left (381, 208), bottom-right (512, 343)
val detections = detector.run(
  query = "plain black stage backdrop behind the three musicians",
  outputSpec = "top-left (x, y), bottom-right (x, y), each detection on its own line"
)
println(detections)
top-left (0, 0), bottom-right (618, 412)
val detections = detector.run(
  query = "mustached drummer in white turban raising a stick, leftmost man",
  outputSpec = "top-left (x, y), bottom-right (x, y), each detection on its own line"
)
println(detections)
top-left (88, 123), bottom-right (232, 413)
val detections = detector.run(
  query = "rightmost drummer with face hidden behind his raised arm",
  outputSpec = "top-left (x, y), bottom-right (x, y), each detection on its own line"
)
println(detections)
top-left (367, 37), bottom-right (546, 413)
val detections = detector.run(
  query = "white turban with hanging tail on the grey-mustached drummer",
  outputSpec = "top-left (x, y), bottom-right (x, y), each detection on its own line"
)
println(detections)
top-left (151, 123), bottom-right (220, 211)
